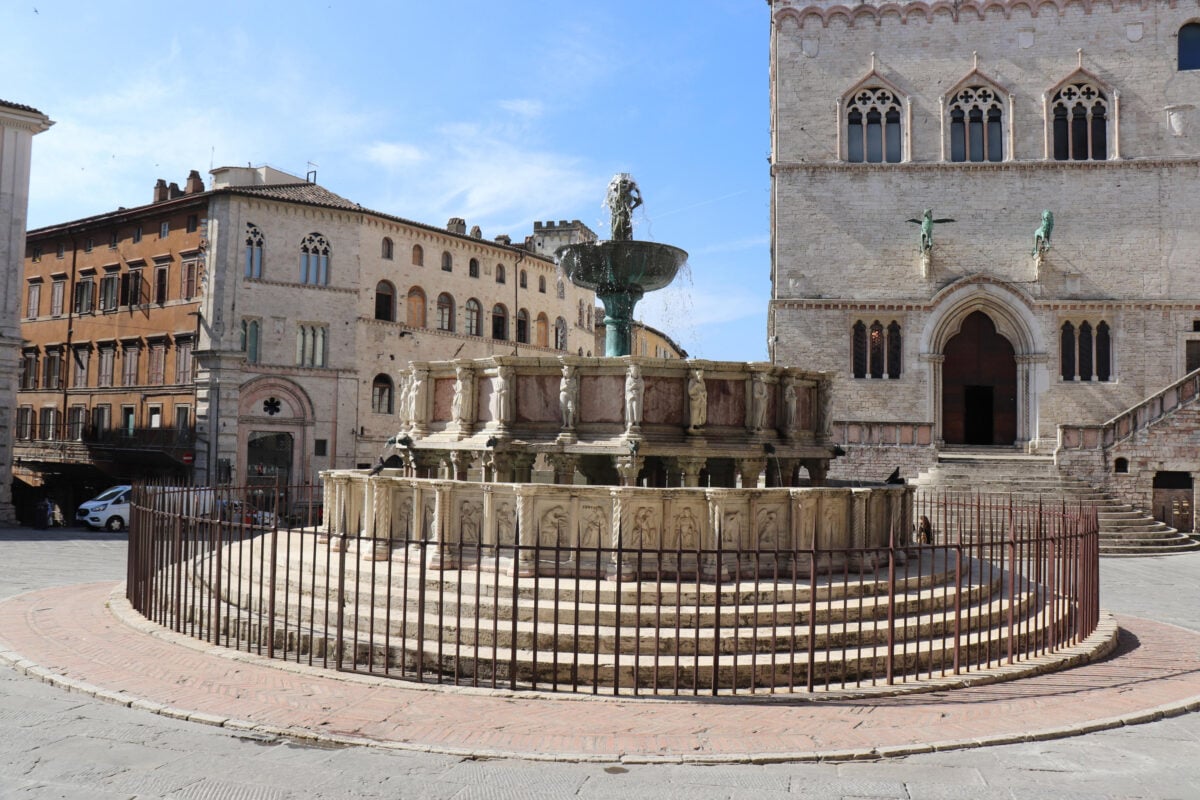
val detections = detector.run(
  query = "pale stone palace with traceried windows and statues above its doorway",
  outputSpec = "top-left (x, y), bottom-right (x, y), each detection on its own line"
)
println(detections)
top-left (768, 0), bottom-right (1200, 476)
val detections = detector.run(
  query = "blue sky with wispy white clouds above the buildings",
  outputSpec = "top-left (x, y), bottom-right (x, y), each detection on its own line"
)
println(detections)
top-left (0, 0), bottom-right (770, 361)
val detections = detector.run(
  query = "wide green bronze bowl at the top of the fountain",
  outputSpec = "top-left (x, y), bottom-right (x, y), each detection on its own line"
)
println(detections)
top-left (554, 240), bottom-right (688, 294)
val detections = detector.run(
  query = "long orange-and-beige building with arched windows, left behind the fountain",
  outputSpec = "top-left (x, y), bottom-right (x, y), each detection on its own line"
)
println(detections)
top-left (17, 167), bottom-right (595, 505)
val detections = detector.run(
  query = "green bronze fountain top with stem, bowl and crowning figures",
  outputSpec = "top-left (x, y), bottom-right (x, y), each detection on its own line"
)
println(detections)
top-left (556, 173), bottom-right (688, 357)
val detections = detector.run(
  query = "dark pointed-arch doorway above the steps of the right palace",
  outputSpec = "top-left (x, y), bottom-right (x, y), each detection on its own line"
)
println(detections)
top-left (942, 311), bottom-right (1018, 445)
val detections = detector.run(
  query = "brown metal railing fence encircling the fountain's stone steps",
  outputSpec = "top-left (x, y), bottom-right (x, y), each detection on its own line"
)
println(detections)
top-left (128, 487), bottom-right (1099, 696)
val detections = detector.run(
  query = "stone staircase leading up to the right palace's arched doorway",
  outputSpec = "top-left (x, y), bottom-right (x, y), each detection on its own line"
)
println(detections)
top-left (913, 449), bottom-right (1200, 557)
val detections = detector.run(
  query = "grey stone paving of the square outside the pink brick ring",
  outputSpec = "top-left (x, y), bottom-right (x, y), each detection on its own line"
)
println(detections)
top-left (0, 529), bottom-right (1200, 800)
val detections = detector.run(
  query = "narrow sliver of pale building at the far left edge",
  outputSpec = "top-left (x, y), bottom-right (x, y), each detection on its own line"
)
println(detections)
top-left (0, 100), bottom-right (54, 524)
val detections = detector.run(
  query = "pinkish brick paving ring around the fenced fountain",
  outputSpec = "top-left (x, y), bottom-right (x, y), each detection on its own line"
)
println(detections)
top-left (0, 582), bottom-right (1200, 762)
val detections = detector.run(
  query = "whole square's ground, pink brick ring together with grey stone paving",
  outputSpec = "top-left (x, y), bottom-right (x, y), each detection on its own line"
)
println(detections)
top-left (0, 530), bottom-right (1200, 798)
